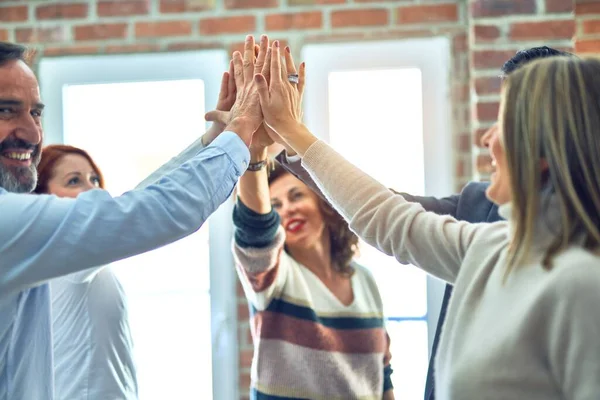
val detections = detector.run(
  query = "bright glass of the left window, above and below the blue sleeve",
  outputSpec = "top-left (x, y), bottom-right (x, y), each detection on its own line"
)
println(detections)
top-left (63, 80), bottom-right (212, 400)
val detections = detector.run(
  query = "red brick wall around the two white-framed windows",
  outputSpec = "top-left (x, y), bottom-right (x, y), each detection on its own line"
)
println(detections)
top-left (0, 0), bottom-right (584, 397)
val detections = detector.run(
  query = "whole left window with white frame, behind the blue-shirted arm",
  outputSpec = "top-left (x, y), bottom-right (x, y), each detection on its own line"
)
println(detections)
top-left (40, 51), bottom-right (238, 400)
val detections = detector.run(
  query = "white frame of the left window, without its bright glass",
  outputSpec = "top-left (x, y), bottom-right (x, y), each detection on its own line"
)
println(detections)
top-left (38, 50), bottom-right (239, 400)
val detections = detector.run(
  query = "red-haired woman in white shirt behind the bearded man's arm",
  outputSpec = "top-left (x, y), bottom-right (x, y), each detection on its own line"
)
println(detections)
top-left (35, 145), bottom-right (137, 400)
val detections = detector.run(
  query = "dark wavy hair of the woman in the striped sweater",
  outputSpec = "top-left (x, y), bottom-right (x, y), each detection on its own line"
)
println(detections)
top-left (269, 162), bottom-right (358, 275)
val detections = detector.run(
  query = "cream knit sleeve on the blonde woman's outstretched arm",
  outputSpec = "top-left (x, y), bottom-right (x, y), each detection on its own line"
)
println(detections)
top-left (302, 141), bottom-right (486, 282)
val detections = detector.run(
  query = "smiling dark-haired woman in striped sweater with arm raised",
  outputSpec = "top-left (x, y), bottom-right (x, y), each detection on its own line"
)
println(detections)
top-left (233, 158), bottom-right (393, 400)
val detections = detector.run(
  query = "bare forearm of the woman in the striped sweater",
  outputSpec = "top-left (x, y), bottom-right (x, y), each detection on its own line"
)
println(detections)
top-left (238, 148), bottom-right (271, 214)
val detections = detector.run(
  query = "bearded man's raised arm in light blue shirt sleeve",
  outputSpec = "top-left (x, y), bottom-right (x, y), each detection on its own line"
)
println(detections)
top-left (0, 134), bottom-right (248, 294)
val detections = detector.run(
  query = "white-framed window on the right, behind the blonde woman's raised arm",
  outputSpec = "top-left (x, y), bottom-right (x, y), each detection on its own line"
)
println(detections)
top-left (303, 39), bottom-right (453, 399)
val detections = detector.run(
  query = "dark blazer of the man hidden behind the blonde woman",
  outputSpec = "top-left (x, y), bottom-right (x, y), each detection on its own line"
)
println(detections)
top-left (276, 152), bottom-right (500, 400)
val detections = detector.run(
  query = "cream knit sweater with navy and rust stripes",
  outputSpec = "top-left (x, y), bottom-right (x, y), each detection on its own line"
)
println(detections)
top-left (233, 201), bottom-right (392, 400)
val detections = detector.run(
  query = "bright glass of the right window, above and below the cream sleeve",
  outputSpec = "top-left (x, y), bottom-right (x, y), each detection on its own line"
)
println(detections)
top-left (328, 68), bottom-right (428, 399)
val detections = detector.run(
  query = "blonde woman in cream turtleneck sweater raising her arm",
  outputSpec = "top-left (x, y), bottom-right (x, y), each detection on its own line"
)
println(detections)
top-left (255, 42), bottom-right (600, 400)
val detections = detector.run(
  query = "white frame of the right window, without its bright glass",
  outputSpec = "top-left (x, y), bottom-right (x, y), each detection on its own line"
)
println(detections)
top-left (301, 37), bottom-right (455, 354)
